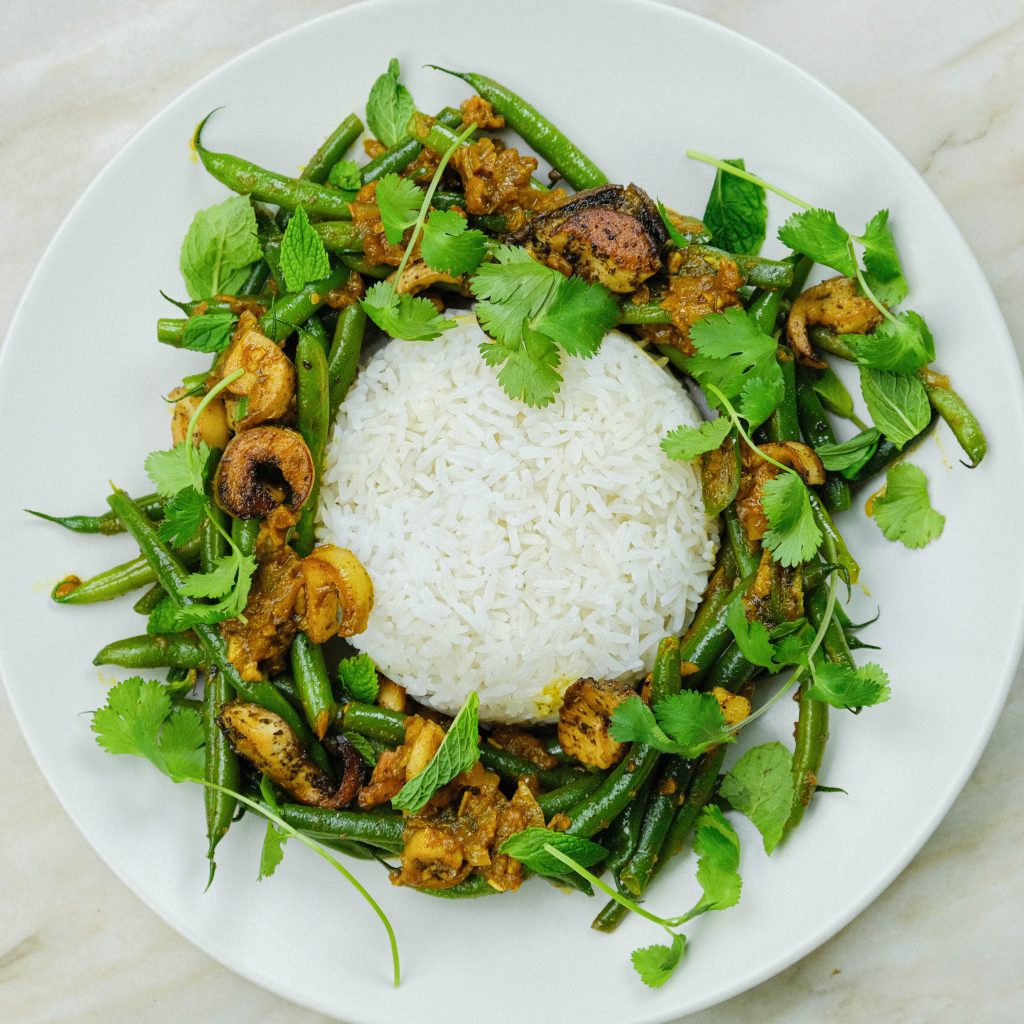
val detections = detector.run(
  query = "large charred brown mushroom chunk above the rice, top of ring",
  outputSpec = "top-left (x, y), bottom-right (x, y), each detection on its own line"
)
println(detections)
top-left (517, 184), bottom-right (667, 293)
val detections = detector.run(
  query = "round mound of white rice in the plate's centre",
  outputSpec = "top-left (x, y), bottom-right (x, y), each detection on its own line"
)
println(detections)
top-left (321, 317), bottom-right (718, 721)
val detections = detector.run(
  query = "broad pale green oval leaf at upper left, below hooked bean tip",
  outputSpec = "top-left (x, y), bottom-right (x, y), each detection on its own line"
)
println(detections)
top-left (179, 196), bottom-right (263, 299)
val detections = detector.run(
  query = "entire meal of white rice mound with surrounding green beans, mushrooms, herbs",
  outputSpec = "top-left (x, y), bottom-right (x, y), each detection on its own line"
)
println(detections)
top-left (34, 60), bottom-right (985, 987)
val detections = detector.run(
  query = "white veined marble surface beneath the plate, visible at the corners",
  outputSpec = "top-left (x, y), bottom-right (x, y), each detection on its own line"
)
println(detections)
top-left (0, 0), bottom-right (1024, 1024)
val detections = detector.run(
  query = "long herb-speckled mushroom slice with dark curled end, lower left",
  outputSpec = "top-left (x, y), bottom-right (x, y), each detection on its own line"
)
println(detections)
top-left (217, 700), bottom-right (362, 808)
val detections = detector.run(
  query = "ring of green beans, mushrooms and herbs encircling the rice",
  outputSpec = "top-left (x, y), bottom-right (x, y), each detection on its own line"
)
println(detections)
top-left (32, 60), bottom-right (986, 986)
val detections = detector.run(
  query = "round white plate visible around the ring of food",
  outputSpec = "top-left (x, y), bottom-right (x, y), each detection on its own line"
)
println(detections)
top-left (0, 0), bottom-right (1024, 1024)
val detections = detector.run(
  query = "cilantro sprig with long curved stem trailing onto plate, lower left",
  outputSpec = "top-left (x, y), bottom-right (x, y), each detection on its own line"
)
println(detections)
top-left (92, 676), bottom-right (400, 986)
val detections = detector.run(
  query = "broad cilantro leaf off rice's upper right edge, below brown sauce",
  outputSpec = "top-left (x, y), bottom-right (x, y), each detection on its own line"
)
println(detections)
top-left (683, 306), bottom-right (782, 404)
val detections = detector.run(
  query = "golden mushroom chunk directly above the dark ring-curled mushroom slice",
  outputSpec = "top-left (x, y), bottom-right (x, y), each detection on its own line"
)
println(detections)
top-left (219, 310), bottom-right (296, 430)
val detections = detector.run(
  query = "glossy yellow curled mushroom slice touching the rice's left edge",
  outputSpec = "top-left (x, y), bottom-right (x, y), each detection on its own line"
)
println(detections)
top-left (300, 544), bottom-right (374, 643)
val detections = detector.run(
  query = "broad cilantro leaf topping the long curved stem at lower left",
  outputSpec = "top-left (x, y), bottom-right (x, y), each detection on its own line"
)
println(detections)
top-left (92, 676), bottom-right (204, 781)
